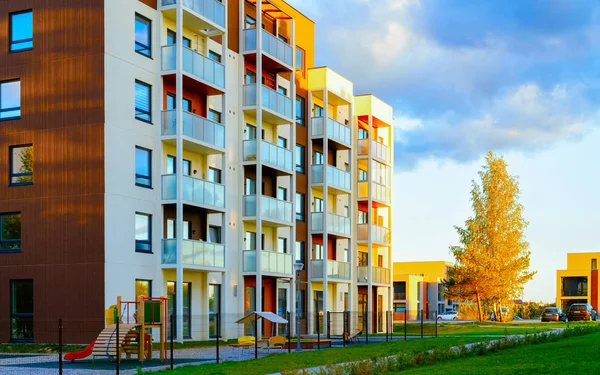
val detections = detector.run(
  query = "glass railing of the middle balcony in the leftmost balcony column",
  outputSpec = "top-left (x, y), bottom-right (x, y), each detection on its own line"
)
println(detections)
top-left (162, 109), bottom-right (225, 148)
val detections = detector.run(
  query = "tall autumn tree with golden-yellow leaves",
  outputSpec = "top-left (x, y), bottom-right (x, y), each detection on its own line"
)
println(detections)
top-left (446, 151), bottom-right (535, 320)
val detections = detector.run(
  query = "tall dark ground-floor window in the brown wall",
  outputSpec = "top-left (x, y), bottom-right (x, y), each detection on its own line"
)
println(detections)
top-left (10, 280), bottom-right (33, 341)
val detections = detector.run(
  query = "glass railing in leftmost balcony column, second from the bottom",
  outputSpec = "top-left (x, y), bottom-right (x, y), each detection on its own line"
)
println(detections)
top-left (162, 174), bottom-right (225, 208)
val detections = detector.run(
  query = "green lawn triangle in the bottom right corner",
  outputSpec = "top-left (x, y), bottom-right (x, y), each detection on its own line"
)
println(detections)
top-left (390, 333), bottom-right (600, 375)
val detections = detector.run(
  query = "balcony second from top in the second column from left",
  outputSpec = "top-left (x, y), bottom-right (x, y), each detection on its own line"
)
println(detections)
top-left (243, 83), bottom-right (293, 125)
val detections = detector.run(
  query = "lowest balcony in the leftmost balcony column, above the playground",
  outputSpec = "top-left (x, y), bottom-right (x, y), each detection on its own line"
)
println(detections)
top-left (161, 238), bottom-right (225, 268)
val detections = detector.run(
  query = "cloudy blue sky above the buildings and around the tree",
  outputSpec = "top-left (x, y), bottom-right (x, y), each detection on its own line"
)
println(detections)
top-left (288, 0), bottom-right (600, 302)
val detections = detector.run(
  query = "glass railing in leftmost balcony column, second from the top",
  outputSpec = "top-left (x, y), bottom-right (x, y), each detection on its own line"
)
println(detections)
top-left (162, 44), bottom-right (225, 89)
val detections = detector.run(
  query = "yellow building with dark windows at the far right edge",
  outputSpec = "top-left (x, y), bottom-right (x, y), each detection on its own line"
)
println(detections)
top-left (556, 252), bottom-right (600, 311)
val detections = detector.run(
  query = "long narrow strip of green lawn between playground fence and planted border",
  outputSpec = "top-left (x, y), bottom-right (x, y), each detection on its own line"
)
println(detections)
top-left (154, 337), bottom-right (488, 375)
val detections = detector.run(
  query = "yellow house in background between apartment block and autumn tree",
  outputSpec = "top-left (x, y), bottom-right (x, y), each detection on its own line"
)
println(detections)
top-left (393, 261), bottom-right (458, 320)
